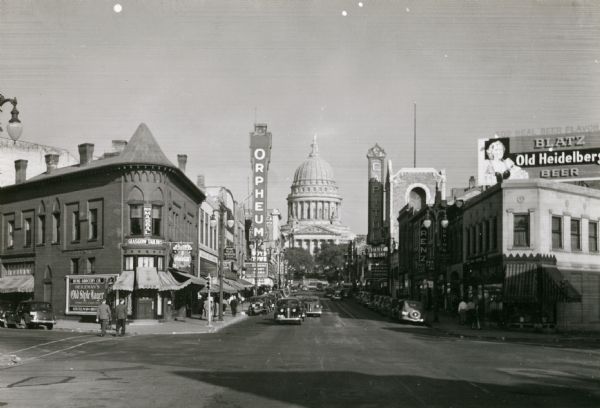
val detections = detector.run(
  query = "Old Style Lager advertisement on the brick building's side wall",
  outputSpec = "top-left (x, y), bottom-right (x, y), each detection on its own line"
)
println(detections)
top-left (65, 275), bottom-right (118, 315)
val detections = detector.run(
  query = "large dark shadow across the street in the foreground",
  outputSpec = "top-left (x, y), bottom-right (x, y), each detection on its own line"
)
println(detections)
top-left (174, 371), bottom-right (600, 408)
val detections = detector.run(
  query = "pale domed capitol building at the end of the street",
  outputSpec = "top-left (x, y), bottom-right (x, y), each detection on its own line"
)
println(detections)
top-left (281, 135), bottom-right (356, 255)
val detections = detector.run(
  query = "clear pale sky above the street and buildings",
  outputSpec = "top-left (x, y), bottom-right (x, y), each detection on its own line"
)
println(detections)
top-left (0, 0), bottom-right (600, 234)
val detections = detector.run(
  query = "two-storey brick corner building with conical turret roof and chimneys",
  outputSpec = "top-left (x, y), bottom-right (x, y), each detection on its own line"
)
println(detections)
top-left (0, 124), bottom-right (205, 319)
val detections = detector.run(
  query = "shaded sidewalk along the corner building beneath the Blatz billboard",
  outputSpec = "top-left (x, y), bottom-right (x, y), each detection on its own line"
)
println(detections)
top-left (431, 312), bottom-right (600, 349)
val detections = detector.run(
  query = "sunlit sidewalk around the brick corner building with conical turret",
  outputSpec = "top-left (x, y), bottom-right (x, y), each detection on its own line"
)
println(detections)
top-left (54, 312), bottom-right (247, 336)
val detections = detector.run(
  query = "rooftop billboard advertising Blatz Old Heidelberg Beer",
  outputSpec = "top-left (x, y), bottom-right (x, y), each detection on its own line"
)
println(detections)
top-left (477, 130), bottom-right (600, 186)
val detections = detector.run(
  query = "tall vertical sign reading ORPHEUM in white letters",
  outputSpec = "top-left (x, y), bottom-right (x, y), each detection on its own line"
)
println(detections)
top-left (250, 123), bottom-right (272, 260)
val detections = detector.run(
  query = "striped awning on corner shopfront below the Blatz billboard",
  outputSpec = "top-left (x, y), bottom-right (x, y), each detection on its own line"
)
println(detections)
top-left (503, 263), bottom-right (539, 303)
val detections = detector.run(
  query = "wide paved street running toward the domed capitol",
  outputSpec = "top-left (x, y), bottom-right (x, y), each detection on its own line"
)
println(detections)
top-left (0, 300), bottom-right (600, 408)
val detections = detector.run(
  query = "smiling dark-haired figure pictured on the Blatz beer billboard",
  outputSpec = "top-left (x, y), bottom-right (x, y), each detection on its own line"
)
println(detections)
top-left (483, 138), bottom-right (529, 185)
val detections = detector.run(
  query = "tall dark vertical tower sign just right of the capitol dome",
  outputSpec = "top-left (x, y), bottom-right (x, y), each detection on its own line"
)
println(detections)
top-left (367, 144), bottom-right (386, 245)
